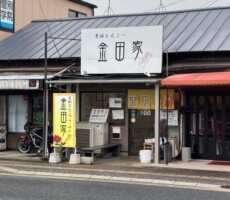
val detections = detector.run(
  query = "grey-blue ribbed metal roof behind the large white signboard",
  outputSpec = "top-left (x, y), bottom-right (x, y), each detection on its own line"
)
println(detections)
top-left (0, 7), bottom-right (230, 60)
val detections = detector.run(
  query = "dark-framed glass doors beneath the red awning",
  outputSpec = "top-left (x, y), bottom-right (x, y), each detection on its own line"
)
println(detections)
top-left (186, 92), bottom-right (230, 160)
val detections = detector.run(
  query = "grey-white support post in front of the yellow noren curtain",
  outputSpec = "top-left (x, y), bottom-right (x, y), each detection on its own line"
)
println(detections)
top-left (155, 83), bottom-right (160, 164)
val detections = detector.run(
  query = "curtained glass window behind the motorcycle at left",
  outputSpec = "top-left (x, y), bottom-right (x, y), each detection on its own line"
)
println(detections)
top-left (8, 95), bottom-right (28, 132)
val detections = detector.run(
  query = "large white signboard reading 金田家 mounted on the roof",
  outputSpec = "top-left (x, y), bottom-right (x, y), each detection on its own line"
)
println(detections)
top-left (81, 26), bottom-right (163, 74)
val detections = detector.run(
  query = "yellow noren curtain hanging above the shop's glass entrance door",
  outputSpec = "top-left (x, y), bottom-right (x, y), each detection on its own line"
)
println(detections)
top-left (128, 89), bottom-right (174, 110)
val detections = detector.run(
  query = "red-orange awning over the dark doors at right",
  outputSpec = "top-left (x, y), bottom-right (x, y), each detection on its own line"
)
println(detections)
top-left (161, 72), bottom-right (230, 86)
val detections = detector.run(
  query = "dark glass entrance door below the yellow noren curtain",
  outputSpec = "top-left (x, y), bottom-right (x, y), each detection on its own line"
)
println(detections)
top-left (129, 109), bottom-right (155, 156)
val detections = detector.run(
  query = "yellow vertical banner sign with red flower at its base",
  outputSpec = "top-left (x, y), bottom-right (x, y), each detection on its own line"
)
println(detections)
top-left (53, 93), bottom-right (76, 148)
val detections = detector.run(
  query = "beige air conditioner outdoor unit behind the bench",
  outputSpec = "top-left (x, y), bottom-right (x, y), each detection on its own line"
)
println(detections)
top-left (76, 122), bottom-right (109, 153)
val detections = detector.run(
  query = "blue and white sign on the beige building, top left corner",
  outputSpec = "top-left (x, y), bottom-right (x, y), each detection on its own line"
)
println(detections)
top-left (0, 0), bottom-right (14, 31)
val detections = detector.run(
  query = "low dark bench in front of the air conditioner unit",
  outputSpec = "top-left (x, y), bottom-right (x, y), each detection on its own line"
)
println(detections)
top-left (81, 144), bottom-right (121, 157)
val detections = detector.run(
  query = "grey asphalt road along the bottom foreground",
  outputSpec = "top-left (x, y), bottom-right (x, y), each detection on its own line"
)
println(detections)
top-left (0, 174), bottom-right (230, 200)
